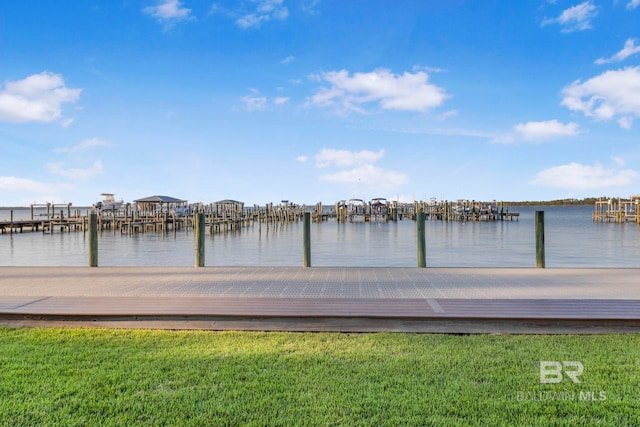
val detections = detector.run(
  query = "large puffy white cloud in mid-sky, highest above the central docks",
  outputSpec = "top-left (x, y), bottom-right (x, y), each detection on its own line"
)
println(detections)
top-left (306, 69), bottom-right (449, 112)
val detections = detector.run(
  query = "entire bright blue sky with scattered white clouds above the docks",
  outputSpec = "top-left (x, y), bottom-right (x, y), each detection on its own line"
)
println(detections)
top-left (0, 0), bottom-right (640, 206)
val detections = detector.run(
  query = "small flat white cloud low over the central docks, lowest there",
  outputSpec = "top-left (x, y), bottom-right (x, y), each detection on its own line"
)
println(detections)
top-left (319, 164), bottom-right (409, 191)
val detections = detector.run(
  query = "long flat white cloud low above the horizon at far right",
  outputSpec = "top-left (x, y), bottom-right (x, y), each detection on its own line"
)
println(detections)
top-left (531, 160), bottom-right (640, 190)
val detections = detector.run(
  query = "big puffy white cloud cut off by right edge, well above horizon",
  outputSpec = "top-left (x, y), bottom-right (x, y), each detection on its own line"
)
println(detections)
top-left (561, 67), bottom-right (640, 127)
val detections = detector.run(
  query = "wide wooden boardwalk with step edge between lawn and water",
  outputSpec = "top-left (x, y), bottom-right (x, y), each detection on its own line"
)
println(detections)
top-left (0, 267), bottom-right (640, 333)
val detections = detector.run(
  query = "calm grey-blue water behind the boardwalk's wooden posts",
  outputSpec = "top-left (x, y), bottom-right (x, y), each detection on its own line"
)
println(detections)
top-left (0, 206), bottom-right (640, 267)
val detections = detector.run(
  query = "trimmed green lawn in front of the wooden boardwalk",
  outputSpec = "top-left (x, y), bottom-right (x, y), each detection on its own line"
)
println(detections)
top-left (0, 327), bottom-right (640, 426)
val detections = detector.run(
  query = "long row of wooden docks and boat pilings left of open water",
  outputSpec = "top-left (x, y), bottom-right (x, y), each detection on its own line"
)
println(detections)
top-left (0, 198), bottom-right (520, 235)
